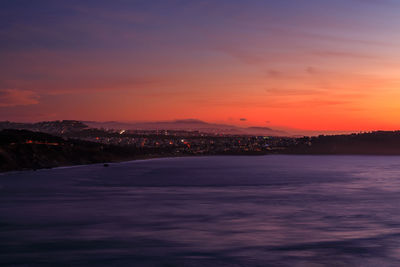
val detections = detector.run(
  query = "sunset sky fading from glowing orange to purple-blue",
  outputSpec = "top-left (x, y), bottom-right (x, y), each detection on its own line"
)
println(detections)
top-left (0, 0), bottom-right (400, 131)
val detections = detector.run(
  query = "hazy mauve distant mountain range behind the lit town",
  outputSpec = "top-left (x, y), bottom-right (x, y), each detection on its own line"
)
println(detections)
top-left (83, 119), bottom-right (289, 136)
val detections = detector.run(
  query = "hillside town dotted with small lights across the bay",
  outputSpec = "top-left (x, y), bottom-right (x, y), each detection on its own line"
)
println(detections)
top-left (73, 130), bottom-right (294, 154)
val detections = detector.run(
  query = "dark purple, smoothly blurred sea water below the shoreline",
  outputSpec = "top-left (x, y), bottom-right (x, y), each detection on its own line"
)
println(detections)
top-left (0, 156), bottom-right (400, 266)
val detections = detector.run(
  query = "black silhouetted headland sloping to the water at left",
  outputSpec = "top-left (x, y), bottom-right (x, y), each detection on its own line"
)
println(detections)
top-left (0, 130), bottom-right (164, 171)
